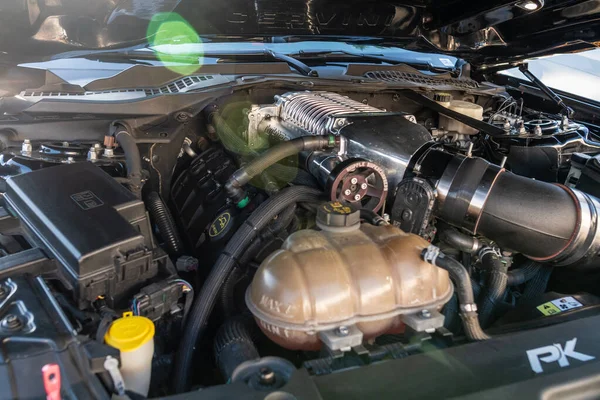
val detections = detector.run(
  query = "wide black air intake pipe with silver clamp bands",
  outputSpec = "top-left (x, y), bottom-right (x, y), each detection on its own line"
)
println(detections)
top-left (420, 150), bottom-right (600, 267)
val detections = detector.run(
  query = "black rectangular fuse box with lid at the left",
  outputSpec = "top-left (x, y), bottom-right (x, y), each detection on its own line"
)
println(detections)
top-left (5, 163), bottom-right (167, 308)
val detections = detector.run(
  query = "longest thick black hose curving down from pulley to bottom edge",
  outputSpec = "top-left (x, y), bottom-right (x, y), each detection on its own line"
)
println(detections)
top-left (173, 186), bottom-right (321, 393)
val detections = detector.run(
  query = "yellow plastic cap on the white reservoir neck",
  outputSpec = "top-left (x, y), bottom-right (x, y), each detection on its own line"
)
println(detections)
top-left (104, 312), bottom-right (154, 351)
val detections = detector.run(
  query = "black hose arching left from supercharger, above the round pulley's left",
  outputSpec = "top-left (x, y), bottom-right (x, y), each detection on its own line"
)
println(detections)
top-left (225, 136), bottom-right (335, 202)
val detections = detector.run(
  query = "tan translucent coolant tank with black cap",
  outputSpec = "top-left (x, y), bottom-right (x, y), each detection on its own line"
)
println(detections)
top-left (246, 203), bottom-right (453, 350)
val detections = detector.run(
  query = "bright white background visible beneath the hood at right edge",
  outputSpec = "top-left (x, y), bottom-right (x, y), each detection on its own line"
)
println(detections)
top-left (501, 49), bottom-right (600, 101)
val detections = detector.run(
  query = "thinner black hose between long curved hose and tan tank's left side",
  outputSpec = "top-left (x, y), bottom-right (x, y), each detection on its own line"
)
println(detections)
top-left (221, 204), bottom-right (296, 317)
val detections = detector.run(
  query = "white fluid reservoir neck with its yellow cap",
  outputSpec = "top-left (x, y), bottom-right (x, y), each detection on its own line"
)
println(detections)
top-left (104, 312), bottom-right (154, 396)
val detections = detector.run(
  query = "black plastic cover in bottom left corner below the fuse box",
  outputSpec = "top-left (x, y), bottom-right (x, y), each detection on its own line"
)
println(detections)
top-left (0, 275), bottom-right (113, 400)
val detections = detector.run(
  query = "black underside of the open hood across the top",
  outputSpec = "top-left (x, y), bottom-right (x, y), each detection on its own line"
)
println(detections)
top-left (0, 0), bottom-right (600, 68)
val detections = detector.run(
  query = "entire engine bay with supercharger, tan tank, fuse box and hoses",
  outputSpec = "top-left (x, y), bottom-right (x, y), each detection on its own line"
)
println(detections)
top-left (0, 68), bottom-right (600, 398)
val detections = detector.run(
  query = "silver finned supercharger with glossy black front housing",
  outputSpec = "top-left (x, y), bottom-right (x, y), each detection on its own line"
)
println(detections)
top-left (247, 91), bottom-right (432, 192)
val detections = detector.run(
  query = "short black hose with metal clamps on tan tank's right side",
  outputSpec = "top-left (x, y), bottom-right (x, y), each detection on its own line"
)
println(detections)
top-left (421, 245), bottom-right (490, 341)
